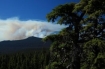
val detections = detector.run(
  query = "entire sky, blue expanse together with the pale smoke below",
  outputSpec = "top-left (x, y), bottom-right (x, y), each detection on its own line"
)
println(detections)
top-left (0, 0), bottom-right (79, 41)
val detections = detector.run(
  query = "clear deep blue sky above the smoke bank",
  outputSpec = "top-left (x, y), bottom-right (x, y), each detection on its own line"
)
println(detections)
top-left (0, 0), bottom-right (79, 21)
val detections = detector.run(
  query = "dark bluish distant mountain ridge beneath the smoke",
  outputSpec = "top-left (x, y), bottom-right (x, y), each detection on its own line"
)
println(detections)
top-left (0, 37), bottom-right (51, 53)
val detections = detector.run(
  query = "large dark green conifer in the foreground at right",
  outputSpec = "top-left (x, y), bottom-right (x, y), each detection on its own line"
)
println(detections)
top-left (44, 0), bottom-right (105, 69)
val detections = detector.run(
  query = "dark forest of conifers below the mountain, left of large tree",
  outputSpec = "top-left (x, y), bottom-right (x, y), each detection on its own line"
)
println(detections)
top-left (0, 49), bottom-right (50, 69)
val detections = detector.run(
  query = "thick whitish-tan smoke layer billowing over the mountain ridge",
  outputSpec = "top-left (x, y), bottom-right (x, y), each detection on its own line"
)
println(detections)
top-left (0, 18), bottom-right (65, 41)
